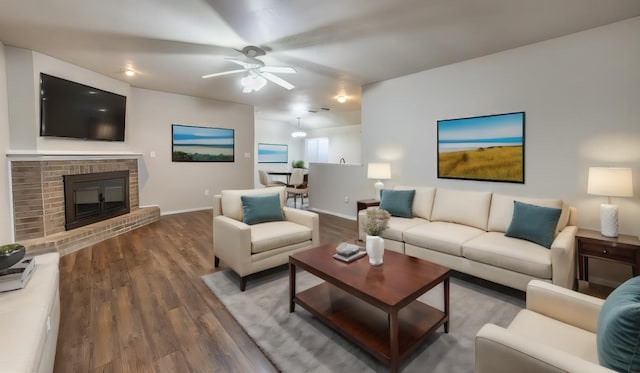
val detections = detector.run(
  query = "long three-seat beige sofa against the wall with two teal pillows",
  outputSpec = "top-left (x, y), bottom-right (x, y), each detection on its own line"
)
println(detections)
top-left (359, 186), bottom-right (577, 291)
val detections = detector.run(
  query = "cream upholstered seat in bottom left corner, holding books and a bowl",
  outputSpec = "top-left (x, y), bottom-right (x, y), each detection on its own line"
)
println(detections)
top-left (0, 253), bottom-right (60, 373)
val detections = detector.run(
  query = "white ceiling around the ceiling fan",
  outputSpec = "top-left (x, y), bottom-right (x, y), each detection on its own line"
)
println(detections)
top-left (0, 0), bottom-right (640, 129)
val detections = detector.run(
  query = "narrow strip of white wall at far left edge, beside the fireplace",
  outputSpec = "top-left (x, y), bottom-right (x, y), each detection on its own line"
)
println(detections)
top-left (0, 43), bottom-right (13, 241)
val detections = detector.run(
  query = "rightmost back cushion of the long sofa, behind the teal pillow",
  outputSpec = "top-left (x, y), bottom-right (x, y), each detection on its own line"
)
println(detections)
top-left (487, 193), bottom-right (569, 232)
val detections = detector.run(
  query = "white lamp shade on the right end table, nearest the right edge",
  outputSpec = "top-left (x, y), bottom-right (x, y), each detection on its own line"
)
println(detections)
top-left (587, 167), bottom-right (633, 197)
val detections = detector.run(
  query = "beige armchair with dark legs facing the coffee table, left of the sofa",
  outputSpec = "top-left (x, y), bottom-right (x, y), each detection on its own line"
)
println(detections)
top-left (213, 187), bottom-right (320, 291)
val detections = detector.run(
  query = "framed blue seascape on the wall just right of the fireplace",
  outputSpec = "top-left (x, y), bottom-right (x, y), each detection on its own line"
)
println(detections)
top-left (171, 124), bottom-right (235, 162)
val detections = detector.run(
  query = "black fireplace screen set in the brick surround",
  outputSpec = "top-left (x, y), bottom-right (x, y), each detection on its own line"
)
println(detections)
top-left (63, 171), bottom-right (129, 230)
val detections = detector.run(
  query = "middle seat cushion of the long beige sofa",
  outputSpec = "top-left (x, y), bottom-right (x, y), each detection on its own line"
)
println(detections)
top-left (403, 221), bottom-right (485, 256)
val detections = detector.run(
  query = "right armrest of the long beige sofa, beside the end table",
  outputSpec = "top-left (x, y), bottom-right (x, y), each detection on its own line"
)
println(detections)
top-left (551, 225), bottom-right (578, 289)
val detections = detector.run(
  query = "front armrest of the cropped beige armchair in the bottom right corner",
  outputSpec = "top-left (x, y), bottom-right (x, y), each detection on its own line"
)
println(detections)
top-left (475, 324), bottom-right (614, 373)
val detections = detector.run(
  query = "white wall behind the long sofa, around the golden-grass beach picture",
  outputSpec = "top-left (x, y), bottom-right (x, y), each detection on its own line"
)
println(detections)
top-left (362, 18), bottom-right (640, 235)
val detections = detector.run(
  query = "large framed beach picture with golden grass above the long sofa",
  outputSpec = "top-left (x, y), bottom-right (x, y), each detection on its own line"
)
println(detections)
top-left (438, 112), bottom-right (525, 184)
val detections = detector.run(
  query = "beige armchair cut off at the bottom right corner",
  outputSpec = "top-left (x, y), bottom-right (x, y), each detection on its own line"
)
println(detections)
top-left (475, 280), bottom-right (613, 373)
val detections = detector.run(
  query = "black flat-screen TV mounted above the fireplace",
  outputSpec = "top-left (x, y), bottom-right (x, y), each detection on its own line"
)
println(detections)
top-left (40, 73), bottom-right (127, 141)
